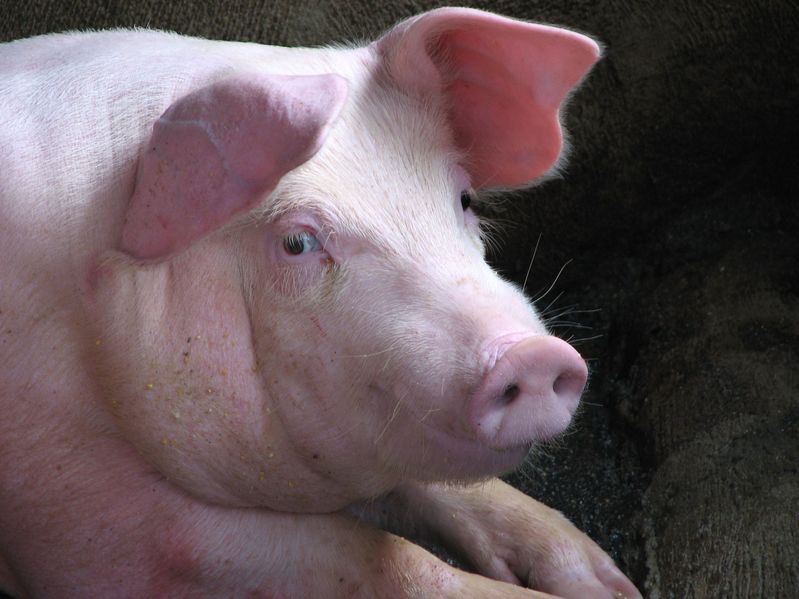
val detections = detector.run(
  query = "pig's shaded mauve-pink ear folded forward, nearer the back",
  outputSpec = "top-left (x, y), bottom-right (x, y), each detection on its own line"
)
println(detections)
top-left (121, 75), bottom-right (347, 258)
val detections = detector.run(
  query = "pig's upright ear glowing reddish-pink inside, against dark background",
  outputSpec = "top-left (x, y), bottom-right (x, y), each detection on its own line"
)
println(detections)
top-left (373, 8), bottom-right (599, 187)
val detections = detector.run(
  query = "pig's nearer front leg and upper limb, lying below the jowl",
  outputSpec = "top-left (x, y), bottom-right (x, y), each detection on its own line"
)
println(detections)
top-left (0, 431), bottom-right (560, 599)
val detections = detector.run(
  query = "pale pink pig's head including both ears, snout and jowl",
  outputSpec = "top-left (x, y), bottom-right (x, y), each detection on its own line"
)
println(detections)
top-left (92, 9), bottom-right (598, 510)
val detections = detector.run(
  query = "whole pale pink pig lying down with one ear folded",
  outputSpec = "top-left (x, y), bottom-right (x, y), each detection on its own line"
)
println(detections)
top-left (0, 8), bottom-right (640, 599)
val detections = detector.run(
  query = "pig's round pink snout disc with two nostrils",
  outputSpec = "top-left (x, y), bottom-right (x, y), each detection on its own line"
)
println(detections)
top-left (468, 335), bottom-right (588, 449)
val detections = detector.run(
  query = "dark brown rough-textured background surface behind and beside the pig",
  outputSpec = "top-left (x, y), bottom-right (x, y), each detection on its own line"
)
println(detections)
top-left (0, 0), bottom-right (799, 599)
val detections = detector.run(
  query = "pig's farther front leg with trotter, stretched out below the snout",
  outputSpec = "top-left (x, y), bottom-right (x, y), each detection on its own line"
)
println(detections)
top-left (360, 479), bottom-right (641, 599)
